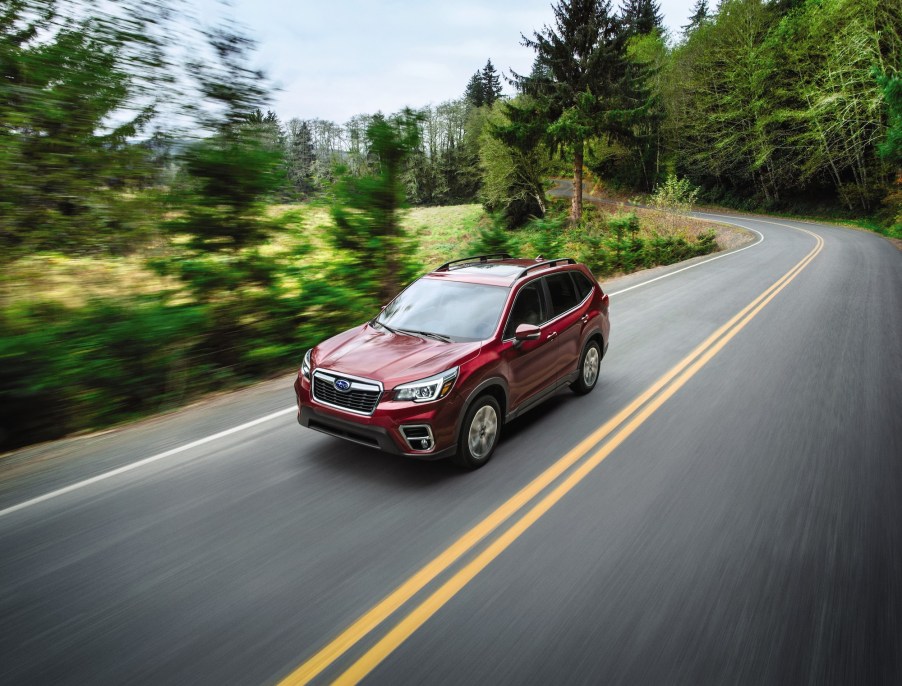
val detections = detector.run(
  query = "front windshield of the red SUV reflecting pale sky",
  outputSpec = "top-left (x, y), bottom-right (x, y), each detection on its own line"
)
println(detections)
top-left (376, 279), bottom-right (508, 341)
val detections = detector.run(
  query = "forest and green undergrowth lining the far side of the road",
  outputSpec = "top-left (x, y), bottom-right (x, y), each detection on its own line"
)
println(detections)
top-left (0, 0), bottom-right (902, 450)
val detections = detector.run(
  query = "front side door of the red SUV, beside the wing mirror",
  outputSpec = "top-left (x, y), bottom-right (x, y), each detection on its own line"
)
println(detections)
top-left (502, 279), bottom-right (556, 410)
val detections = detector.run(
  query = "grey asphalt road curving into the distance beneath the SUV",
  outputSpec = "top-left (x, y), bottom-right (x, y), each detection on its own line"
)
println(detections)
top-left (0, 211), bottom-right (902, 685)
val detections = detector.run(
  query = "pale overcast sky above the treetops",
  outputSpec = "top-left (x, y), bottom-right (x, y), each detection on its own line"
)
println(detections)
top-left (215, 0), bottom-right (693, 123)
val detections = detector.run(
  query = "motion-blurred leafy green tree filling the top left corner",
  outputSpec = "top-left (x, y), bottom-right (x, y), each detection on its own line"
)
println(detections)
top-left (0, 0), bottom-right (157, 257)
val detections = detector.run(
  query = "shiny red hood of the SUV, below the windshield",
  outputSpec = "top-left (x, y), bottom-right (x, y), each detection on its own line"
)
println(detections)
top-left (313, 324), bottom-right (482, 388)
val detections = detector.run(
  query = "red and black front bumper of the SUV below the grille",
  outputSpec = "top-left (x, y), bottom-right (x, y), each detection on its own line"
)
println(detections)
top-left (294, 375), bottom-right (460, 460)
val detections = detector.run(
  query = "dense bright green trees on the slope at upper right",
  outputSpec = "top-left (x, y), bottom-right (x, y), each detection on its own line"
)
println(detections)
top-left (661, 0), bottom-right (902, 218)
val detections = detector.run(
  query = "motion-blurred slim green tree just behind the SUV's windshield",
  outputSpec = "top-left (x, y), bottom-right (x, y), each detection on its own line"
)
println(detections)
top-left (329, 109), bottom-right (421, 303)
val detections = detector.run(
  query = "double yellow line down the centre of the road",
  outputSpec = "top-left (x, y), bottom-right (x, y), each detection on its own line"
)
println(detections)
top-left (281, 222), bottom-right (824, 686)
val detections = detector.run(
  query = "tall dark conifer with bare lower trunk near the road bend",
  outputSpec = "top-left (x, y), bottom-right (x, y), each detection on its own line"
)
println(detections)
top-left (509, 0), bottom-right (624, 223)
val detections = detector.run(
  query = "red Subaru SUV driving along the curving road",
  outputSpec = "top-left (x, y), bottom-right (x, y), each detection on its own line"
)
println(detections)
top-left (294, 254), bottom-right (610, 469)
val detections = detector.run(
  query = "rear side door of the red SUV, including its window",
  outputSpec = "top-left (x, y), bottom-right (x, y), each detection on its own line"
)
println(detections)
top-left (543, 271), bottom-right (587, 381)
